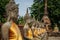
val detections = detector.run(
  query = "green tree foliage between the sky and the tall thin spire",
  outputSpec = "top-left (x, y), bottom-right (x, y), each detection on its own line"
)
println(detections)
top-left (30, 0), bottom-right (44, 20)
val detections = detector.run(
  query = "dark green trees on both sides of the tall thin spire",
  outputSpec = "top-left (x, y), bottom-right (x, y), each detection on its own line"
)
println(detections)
top-left (30, 0), bottom-right (60, 29)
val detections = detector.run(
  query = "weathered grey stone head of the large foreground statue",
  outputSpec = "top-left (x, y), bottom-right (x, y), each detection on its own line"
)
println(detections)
top-left (6, 0), bottom-right (18, 19)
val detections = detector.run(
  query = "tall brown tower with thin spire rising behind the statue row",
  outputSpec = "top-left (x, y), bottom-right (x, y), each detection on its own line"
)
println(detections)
top-left (41, 0), bottom-right (51, 30)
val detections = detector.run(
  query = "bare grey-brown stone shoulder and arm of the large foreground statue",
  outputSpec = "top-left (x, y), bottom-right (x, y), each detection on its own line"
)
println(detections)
top-left (1, 22), bottom-right (11, 40)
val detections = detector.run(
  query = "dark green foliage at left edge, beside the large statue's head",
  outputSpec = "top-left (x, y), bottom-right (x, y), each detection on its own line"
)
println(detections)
top-left (0, 0), bottom-right (9, 23)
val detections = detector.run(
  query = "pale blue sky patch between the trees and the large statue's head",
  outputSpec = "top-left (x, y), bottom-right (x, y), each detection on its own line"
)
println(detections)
top-left (15, 0), bottom-right (33, 16)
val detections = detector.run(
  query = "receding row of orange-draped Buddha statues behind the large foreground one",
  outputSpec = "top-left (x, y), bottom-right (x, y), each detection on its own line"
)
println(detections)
top-left (23, 9), bottom-right (47, 40)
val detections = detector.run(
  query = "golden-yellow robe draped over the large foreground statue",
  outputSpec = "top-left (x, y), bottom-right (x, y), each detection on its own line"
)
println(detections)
top-left (9, 22), bottom-right (22, 40)
